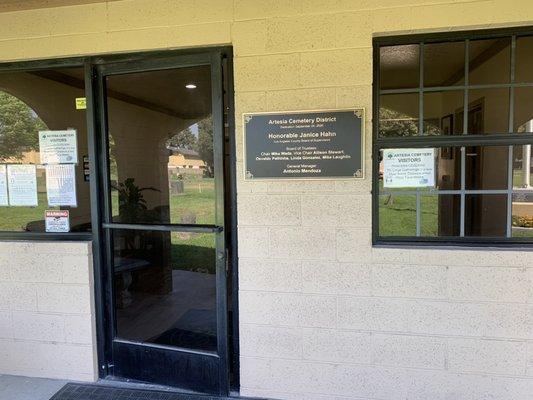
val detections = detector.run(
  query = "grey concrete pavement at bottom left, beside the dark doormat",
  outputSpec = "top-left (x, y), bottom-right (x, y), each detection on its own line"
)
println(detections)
top-left (0, 375), bottom-right (66, 400)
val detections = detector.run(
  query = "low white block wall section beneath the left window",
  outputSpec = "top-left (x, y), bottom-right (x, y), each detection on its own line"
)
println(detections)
top-left (0, 242), bottom-right (97, 381)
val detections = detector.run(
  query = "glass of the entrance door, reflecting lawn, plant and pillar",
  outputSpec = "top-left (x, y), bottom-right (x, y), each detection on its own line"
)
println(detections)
top-left (106, 66), bottom-right (217, 351)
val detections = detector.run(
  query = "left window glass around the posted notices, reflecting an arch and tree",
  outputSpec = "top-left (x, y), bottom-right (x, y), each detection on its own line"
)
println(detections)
top-left (0, 68), bottom-right (91, 232)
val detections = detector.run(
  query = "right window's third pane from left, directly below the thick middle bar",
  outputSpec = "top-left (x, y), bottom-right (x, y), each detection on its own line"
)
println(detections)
top-left (465, 146), bottom-right (509, 190)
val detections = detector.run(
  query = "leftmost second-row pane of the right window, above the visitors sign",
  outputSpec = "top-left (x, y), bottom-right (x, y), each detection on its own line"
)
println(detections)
top-left (379, 93), bottom-right (419, 137)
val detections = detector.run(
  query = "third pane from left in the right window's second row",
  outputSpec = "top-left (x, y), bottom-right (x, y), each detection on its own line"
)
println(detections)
top-left (468, 88), bottom-right (509, 135)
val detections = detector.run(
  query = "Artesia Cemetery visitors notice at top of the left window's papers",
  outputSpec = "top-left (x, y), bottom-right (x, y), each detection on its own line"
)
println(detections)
top-left (39, 129), bottom-right (78, 164)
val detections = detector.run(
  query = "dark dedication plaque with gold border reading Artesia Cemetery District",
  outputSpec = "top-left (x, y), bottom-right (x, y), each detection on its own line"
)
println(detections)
top-left (243, 109), bottom-right (365, 180)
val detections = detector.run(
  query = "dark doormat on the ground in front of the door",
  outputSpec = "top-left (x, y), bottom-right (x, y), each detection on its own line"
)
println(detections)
top-left (50, 383), bottom-right (260, 400)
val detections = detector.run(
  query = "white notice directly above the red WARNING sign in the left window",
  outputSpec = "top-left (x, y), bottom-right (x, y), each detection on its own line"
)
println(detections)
top-left (46, 164), bottom-right (78, 207)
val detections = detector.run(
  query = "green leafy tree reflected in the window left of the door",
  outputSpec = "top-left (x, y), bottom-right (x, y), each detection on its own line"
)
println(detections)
top-left (0, 91), bottom-right (47, 160)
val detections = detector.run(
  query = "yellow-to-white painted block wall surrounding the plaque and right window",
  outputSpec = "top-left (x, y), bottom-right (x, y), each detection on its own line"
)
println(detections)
top-left (0, 0), bottom-right (533, 400)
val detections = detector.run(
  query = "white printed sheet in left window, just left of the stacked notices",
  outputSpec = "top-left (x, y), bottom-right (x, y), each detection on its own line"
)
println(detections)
top-left (7, 164), bottom-right (38, 207)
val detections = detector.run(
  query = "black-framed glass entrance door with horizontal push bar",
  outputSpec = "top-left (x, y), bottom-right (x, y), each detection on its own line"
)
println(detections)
top-left (97, 54), bottom-right (228, 394)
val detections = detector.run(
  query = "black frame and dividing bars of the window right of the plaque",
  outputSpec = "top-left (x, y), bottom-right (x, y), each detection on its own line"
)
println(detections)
top-left (372, 27), bottom-right (533, 247)
